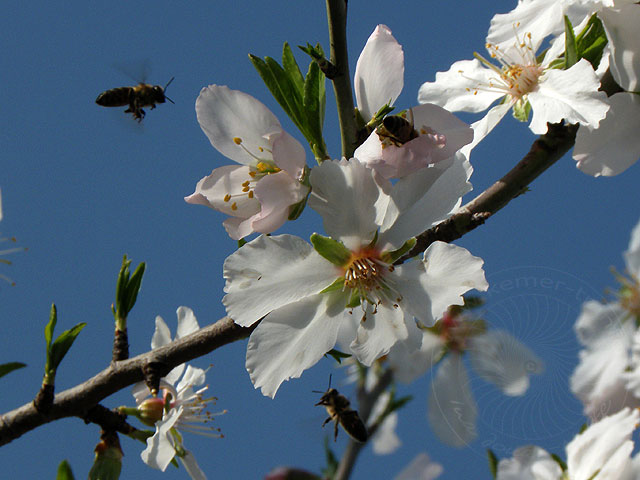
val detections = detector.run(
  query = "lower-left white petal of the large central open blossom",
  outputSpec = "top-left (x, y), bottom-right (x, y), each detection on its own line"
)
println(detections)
top-left (243, 292), bottom-right (345, 398)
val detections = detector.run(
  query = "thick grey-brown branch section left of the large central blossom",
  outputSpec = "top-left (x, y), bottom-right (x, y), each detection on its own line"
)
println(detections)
top-left (0, 317), bottom-right (254, 445)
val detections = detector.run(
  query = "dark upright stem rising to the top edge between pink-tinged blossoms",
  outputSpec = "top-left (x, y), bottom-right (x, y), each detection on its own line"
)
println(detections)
top-left (327, 0), bottom-right (357, 159)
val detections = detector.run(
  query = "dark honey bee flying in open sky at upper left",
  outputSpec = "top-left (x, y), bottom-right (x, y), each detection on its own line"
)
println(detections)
top-left (96, 77), bottom-right (175, 122)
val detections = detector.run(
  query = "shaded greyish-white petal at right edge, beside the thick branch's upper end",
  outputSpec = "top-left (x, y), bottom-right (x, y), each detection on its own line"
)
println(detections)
top-left (573, 92), bottom-right (640, 177)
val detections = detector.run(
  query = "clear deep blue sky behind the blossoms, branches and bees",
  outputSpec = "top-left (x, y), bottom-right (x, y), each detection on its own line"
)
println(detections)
top-left (0, 0), bottom-right (640, 479)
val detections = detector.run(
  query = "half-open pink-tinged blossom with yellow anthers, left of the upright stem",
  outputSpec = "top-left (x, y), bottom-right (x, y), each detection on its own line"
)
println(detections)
top-left (185, 85), bottom-right (308, 240)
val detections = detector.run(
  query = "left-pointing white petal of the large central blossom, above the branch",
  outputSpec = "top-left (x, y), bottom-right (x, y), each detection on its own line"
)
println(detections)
top-left (222, 235), bottom-right (341, 327)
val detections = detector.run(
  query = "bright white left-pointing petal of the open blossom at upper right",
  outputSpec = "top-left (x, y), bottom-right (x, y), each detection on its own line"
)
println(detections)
top-left (418, 59), bottom-right (504, 112)
